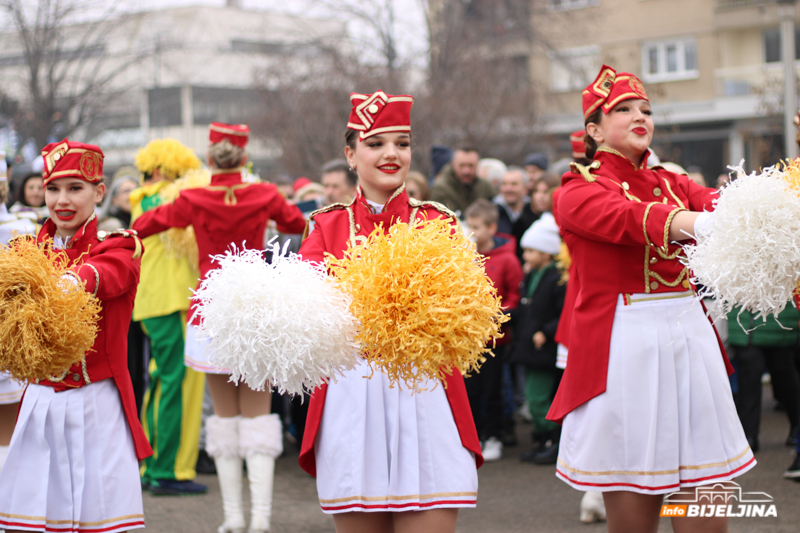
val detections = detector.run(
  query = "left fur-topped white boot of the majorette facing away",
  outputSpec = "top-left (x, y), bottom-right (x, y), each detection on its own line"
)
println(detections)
top-left (206, 415), bottom-right (247, 533)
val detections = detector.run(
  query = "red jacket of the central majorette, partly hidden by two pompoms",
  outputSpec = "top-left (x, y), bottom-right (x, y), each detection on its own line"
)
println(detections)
top-left (299, 186), bottom-right (483, 476)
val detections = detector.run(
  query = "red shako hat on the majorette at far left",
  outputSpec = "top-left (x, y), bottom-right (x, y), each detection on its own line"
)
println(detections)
top-left (42, 139), bottom-right (105, 186)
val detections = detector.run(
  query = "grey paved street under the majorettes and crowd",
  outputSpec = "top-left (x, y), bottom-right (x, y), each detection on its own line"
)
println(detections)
top-left (145, 391), bottom-right (800, 533)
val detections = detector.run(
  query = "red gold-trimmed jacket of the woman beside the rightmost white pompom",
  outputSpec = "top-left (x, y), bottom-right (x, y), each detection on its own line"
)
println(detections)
top-left (547, 148), bottom-right (733, 422)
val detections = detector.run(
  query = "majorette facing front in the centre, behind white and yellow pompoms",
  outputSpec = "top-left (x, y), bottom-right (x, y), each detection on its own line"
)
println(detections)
top-left (300, 91), bottom-right (483, 533)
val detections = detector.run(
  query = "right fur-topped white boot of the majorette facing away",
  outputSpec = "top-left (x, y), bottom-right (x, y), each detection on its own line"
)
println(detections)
top-left (239, 415), bottom-right (283, 533)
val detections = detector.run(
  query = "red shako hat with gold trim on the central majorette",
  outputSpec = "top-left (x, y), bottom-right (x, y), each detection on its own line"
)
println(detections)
top-left (347, 91), bottom-right (414, 141)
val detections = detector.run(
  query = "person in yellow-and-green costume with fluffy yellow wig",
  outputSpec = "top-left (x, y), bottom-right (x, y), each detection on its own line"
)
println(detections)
top-left (130, 139), bottom-right (208, 495)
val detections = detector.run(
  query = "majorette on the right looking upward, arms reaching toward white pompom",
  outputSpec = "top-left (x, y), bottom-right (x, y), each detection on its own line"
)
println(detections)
top-left (548, 66), bottom-right (755, 532)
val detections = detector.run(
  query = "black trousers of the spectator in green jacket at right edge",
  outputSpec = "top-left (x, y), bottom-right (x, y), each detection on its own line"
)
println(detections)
top-left (732, 346), bottom-right (800, 438)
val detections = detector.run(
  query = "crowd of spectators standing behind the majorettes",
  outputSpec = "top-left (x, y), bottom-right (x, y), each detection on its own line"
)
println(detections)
top-left (7, 140), bottom-right (800, 480)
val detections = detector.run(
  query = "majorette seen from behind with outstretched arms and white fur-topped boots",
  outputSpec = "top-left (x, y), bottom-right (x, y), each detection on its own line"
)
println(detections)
top-left (133, 122), bottom-right (305, 533)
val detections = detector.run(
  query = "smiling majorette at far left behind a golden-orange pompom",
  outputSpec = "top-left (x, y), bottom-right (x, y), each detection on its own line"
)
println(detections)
top-left (0, 139), bottom-right (152, 532)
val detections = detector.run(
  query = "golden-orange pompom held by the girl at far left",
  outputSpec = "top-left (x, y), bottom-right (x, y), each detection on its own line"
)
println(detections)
top-left (0, 239), bottom-right (102, 382)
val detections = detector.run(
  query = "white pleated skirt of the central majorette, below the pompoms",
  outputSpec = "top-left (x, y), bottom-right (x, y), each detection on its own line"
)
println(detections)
top-left (314, 363), bottom-right (478, 514)
